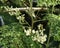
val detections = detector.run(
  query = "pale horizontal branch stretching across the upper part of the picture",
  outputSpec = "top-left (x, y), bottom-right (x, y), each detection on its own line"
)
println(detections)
top-left (3, 7), bottom-right (60, 13)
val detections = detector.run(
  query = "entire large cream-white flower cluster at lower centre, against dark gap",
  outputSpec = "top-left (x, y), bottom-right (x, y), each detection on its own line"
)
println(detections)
top-left (24, 24), bottom-right (47, 44)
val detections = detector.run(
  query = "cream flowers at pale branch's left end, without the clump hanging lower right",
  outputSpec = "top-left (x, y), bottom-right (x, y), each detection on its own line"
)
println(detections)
top-left (1, 6), bottom-right (21, 16)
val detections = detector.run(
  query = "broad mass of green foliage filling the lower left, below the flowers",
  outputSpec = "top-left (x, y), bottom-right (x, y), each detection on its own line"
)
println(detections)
top-left (0, 23), bottom-right (42, 48)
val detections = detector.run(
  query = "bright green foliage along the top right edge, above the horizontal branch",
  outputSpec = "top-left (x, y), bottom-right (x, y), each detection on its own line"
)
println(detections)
top-left (37, 0), bottom-right (60, 7)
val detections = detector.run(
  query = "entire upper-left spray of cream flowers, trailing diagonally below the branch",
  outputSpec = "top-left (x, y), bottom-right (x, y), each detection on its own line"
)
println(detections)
top-left (1, 6), bottom-right (25, 22)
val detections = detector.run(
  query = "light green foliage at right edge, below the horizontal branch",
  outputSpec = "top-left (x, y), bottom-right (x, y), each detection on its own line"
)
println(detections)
top-left (45, 14), bottom-right (60, 41)
